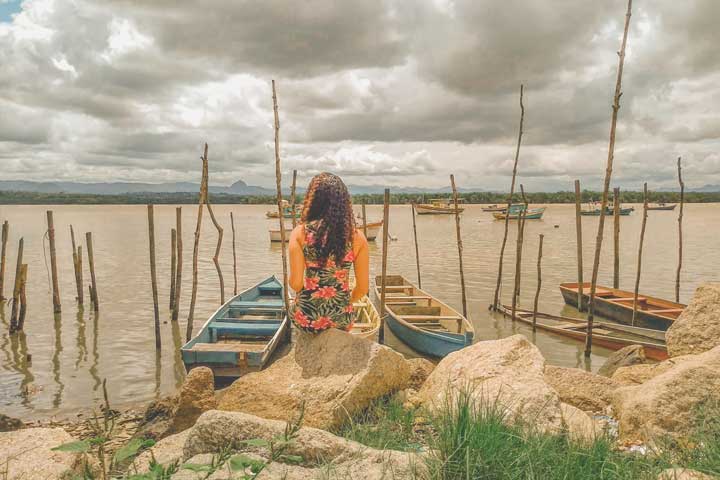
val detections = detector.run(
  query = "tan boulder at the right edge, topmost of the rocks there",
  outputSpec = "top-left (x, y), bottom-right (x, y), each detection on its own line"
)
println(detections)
top-left (665, 283), bottom-right (720, 357)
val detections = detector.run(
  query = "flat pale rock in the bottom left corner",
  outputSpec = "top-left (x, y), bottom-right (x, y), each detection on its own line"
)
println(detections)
top-left (0, 428), bottom-right (80, 480)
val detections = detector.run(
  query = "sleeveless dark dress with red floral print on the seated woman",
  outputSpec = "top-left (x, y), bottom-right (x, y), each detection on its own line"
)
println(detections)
top-left (290, 221), bottom-right (355, 333)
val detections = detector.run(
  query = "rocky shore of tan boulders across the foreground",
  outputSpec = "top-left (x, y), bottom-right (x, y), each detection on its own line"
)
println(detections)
top-left (0, 284), bottom-right (720, 480)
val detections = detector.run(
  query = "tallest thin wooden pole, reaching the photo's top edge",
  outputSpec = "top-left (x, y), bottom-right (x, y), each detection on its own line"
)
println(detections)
top-left (585, 0), bottom-right (632, 357)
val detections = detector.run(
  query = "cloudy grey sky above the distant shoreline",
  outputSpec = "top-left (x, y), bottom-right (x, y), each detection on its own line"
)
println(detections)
top-left (0, 0), bottom-right (720, 190)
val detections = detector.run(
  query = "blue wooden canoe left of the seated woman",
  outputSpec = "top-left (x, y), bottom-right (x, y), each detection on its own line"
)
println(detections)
top-left (181, 276), bottom-right (289, 377)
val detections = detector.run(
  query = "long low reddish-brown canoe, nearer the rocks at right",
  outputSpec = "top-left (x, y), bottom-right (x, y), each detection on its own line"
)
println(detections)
top-left (500, 305), bottom-right (668, 360)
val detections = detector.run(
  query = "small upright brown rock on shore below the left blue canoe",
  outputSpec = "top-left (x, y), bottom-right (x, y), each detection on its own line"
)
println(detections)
top-left (170, 367), bottom-right (217, 433)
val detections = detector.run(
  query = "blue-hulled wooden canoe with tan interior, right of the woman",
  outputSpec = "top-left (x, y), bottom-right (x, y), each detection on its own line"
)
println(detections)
top-left (375, 275), bottom-right (475, 357)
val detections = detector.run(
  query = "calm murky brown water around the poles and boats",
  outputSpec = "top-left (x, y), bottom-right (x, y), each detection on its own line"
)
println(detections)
top-left (0, 204), bottom-right (720, 418)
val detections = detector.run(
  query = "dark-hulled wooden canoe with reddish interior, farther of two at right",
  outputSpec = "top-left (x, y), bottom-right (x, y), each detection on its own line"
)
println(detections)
top-left (560, 282), bottom-right (686, 330)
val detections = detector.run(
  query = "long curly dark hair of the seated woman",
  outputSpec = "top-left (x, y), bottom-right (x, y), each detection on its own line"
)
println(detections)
top-left (302, 172), bottom-right (355, 260)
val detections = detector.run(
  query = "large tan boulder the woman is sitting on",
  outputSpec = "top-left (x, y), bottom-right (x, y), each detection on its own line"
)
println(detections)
top-left (218, 329), bottom-right (411, 429)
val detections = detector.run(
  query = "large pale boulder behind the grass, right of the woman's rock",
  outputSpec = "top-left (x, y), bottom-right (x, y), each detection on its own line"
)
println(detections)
top-left (419, 335), bottom-right (585, 431)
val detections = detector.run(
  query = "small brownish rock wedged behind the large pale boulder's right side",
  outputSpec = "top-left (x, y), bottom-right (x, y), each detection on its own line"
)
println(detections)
top-left (545, 365), bottom-right (621, 412)
